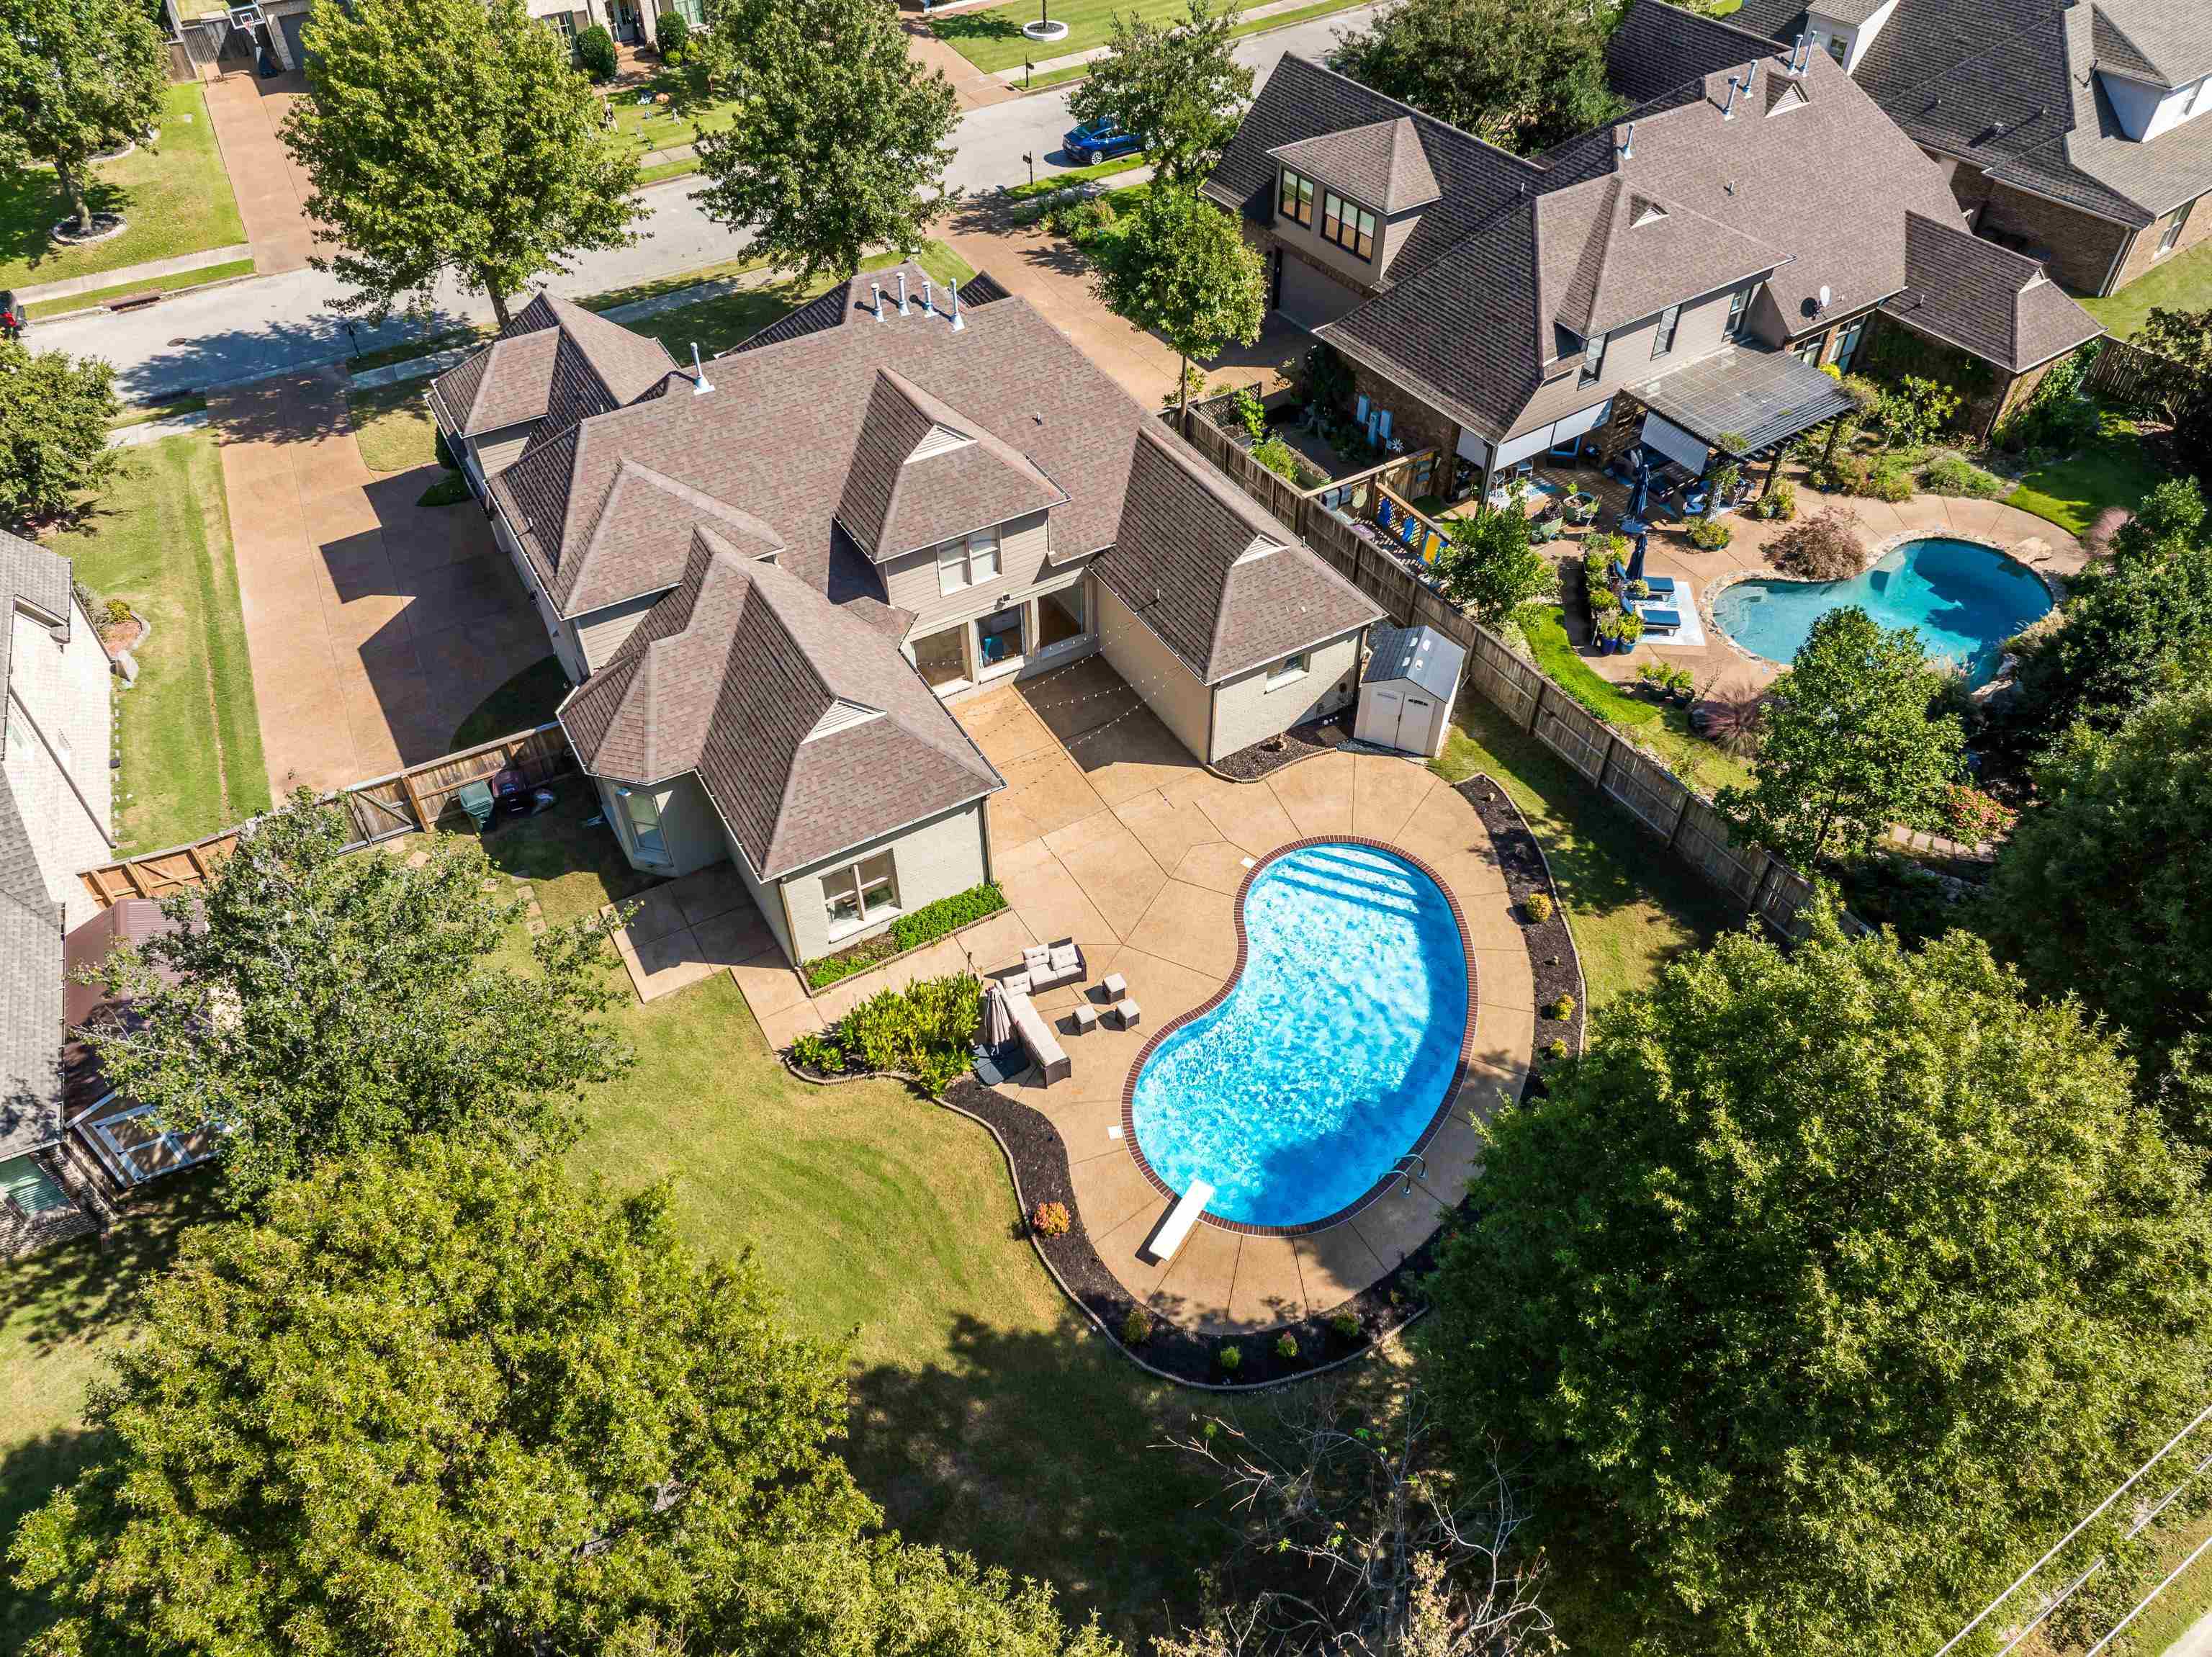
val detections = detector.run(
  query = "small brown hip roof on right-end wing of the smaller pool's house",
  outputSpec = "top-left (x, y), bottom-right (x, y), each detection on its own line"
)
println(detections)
top-left (1882, 212), bottom-right (2103, 374)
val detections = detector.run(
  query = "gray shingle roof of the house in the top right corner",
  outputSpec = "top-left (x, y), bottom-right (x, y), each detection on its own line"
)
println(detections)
top-left (1737, 0), bottom-right (2212, 228)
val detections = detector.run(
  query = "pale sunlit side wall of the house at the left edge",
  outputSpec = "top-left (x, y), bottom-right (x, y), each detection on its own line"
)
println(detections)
top-left (4, 600), bottom-right (115, 927)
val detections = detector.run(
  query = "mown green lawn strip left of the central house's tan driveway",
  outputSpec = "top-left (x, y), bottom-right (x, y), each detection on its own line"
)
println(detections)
top-left (53, 429), bottom-right (270, 852)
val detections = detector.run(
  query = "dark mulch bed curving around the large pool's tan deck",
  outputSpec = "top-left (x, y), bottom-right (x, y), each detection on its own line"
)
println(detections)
top-left (792, 765), bottom-right (1584, 1389)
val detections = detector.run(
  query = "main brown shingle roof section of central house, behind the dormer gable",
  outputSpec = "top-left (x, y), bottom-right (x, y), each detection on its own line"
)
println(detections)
top-left (491, 268), bottom-right (1150, 615)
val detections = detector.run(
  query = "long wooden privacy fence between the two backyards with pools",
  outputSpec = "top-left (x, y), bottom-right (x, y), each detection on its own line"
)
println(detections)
top-left (1190, 421), bottom-right (1812, 938)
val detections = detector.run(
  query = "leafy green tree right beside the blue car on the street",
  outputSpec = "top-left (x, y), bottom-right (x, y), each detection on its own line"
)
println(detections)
top-left (1069, 0), bottom-right (1252, 184)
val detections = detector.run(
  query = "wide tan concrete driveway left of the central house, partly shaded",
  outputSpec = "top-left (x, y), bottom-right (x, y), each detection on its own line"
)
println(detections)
top-left (208, 372), bottom-right (551, 794)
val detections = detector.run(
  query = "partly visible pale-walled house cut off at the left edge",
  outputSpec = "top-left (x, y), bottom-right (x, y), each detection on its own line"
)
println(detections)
top-left (0, 533), bottom-right (115, 1252)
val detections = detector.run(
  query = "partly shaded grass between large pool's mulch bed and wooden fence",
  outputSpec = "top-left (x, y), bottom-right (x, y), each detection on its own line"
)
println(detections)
top-left (1431, 690), bottom-right (1743, 1007)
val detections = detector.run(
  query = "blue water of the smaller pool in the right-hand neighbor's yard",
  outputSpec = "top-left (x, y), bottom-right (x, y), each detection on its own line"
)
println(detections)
top-left (1712, 538), bottom-right (2051, 683)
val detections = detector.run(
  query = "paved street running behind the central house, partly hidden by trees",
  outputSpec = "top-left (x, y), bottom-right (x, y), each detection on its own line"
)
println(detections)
top-left (33, 11), bottom-right (1374, 403)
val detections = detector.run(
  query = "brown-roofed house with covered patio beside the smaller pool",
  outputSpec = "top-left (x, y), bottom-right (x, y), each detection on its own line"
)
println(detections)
top-left (1205, 0), bottom-right (2099, 489)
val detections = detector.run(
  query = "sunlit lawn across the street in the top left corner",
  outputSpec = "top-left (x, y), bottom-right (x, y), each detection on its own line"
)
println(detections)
top-left (0, 84), bottom-right (246, 289)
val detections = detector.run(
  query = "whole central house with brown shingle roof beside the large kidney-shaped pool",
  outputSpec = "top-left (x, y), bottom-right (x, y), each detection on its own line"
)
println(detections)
top-left (431, 266), bottom-right (1378, 962)
